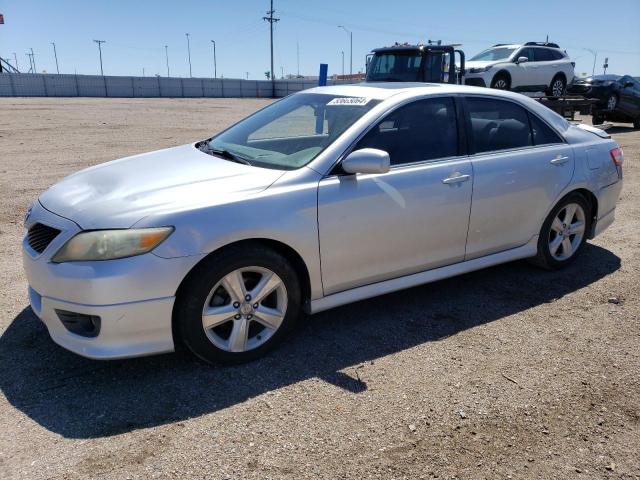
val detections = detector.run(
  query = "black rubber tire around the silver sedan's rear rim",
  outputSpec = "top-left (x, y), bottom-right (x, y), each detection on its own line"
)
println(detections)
top-left (529, 192), bottom-right (591, 270)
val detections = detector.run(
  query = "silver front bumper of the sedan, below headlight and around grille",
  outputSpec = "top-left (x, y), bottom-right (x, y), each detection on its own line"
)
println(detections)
top-left (22, 202), bottom-right (203, 359)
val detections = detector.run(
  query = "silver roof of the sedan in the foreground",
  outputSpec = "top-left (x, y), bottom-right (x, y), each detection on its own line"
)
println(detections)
top-left (304, 82), bottom-right (569, 132)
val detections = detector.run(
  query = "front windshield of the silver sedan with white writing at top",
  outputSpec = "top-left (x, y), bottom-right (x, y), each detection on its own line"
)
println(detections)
top-left (206, 93), bottom-right (380, 170)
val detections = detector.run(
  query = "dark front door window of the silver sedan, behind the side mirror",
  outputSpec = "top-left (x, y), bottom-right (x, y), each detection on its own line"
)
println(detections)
top-left (355, 97), bottom-right (458, 165)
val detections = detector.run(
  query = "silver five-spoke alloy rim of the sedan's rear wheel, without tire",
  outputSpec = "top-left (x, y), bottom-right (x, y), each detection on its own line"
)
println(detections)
top-left (549, 203), bottom-right (586, 261)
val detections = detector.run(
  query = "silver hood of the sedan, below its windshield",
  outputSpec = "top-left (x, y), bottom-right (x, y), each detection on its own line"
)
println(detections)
top-left (39, 144), bottom-right (284, 230)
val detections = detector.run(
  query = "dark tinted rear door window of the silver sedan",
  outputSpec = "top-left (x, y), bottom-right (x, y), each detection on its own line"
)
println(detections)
top-left (466, 97), bottom-right (533, 153)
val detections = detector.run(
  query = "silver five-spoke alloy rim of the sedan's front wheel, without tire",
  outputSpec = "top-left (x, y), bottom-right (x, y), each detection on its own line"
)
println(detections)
top-left (202, 266), bottom-right (287, 352)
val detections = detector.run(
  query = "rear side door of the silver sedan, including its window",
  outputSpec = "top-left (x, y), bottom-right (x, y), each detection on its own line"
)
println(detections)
top-left (465, 97), bottom-right (574, 260)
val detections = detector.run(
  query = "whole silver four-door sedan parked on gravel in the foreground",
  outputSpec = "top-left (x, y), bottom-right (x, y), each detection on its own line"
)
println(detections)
top-left (23, 84), bottom-right (623, 362)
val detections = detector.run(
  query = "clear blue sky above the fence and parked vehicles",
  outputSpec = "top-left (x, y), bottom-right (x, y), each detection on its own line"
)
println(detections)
top-left (0, 0), bottom-right (640, 79)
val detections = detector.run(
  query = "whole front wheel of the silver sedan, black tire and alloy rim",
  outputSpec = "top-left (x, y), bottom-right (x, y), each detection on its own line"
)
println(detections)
top-left (174, 245), bottom-right (301, 363)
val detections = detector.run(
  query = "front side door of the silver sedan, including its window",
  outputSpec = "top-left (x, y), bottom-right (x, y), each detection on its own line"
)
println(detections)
top-left (318, 97), bottom-right (472, 295)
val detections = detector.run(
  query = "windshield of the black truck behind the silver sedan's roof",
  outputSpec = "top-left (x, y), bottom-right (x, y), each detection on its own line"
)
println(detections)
top-left (367, 51), bottom-right (423, 82)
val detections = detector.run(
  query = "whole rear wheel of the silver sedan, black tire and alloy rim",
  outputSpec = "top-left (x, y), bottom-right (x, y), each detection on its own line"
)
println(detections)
top-left (531, 193), bottom-right (591, 270)
